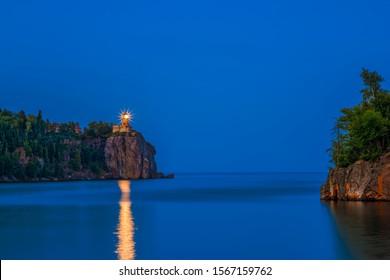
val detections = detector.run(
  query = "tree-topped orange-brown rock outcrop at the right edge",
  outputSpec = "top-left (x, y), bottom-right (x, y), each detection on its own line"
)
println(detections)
top-left (321, 68), bottom-right (390, 201)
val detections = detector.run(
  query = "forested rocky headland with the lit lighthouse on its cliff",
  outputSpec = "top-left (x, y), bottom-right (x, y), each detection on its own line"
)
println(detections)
top-left (0, 109), bottom-right (173, 183)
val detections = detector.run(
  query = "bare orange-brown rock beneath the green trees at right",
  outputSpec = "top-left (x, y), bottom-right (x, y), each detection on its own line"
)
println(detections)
top-left (321, 153), bottom-right (390, 201)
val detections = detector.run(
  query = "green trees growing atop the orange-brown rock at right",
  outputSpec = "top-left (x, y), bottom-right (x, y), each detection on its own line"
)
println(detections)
top-left (329, 68), bottom-right (390, 167)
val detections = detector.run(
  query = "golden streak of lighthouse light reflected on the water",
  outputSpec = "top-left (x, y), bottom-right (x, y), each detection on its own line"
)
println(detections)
top-left (115, 180), bottom-right (135, 260)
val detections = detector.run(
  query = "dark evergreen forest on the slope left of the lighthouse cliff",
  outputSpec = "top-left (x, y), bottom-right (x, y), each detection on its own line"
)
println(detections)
top-left (0, 109), bottom-right (113, 180)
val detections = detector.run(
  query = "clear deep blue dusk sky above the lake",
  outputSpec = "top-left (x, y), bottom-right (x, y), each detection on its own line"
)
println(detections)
top-left (0, 0), bottom-right (390, 172)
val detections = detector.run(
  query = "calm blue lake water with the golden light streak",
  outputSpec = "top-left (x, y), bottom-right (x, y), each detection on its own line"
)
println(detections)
top-left (0, 173), bottom-right (390, 259)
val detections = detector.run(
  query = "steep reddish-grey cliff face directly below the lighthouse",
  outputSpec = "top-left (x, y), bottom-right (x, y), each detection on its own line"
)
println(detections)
top-left (104, 132), bottom-right (158, 179)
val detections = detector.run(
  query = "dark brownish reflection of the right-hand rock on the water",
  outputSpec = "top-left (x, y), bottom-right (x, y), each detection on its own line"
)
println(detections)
top-left (328, 201), bottom-right (390, 259)
